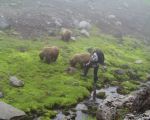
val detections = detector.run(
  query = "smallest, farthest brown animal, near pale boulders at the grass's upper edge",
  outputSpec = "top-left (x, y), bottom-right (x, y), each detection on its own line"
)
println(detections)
top-left (61, 28), bottom-right (72, 42)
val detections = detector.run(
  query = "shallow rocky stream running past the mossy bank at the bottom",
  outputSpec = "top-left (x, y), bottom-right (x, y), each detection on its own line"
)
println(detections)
top-left (53, 86), bottom-right (124, 120)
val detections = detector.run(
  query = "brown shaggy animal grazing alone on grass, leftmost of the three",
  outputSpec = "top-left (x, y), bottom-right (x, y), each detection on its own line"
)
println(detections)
top-left (39, 46), bottom-right (59, 64)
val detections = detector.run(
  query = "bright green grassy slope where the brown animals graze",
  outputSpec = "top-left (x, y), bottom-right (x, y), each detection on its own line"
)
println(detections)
top-left (0, 31), bottom-right (150, 118)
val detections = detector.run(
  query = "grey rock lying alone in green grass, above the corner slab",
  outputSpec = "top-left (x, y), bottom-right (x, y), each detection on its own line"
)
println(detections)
top-left (9, 76), bottom-right (24, 87)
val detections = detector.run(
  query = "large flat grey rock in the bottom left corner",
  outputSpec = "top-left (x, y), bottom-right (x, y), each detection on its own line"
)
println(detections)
top-left (0, 102), bottom-right (26, 120)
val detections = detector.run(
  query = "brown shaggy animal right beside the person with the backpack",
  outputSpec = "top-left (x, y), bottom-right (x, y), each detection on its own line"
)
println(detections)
top-left (70, 53), bottom-right (90, 68)
